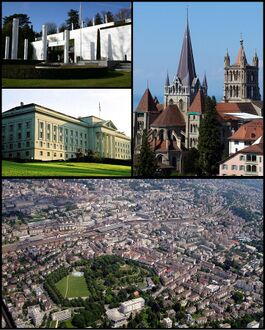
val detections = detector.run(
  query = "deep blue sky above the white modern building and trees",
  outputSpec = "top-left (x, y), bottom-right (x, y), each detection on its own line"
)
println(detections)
top-left (2, 1), bottom-right (130, 32)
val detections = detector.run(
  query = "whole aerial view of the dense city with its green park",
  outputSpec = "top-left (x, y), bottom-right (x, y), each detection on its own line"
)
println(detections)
top-left (2, 179), bottom-right (263, 328)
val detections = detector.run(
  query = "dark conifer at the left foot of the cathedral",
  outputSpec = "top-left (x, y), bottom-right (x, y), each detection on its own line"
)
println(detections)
top-left (136, 130), bottom-right (158, 177)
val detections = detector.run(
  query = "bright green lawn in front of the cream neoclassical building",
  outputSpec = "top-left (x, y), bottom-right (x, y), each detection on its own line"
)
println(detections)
top-left (2, 160), bottom-right (131, 176)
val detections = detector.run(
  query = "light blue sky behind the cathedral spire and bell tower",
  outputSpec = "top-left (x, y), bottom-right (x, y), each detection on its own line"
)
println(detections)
top-left (133, 1), bottom-right (263, 108)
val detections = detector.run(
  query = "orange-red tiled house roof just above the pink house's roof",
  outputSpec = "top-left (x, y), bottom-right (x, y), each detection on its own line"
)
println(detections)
top-left (229, 119), bottom-right (263, 142)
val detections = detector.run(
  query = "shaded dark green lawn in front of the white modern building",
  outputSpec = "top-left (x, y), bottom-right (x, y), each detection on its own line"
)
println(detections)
top-left (2, 71), bottom-right (131, 88)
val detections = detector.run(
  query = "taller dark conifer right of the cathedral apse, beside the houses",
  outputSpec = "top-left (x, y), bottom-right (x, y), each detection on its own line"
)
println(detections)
top-left (198, 96), bottom-right (222, 176)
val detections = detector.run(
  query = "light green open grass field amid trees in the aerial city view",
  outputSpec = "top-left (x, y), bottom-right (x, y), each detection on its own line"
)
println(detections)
top-left (55, 275), bottom-right (89, 298)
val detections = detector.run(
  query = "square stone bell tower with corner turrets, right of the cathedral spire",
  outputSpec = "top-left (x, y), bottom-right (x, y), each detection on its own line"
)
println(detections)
top-left (223, 38), bottom-right (261, 102)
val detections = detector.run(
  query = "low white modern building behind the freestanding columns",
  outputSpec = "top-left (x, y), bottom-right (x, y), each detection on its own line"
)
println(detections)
top-left (32, 19), bottom-right (131, 63)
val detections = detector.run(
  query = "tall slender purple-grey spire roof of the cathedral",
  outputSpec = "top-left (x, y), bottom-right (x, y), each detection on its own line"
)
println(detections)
top-left (177, 20), bottom-right (196, 86)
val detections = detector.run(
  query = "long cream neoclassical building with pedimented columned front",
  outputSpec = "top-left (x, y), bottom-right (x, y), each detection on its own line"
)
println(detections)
top-left (2, 103), bottom-right (131, 161)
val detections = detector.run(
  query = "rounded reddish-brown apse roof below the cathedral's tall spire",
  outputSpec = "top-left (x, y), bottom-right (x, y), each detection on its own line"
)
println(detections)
top-left (151, 104), bottom-right (185, 127)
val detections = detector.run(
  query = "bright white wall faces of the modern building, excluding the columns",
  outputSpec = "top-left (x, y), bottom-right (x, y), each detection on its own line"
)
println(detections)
top-left (32, 22), bottom-right (131, 62)
